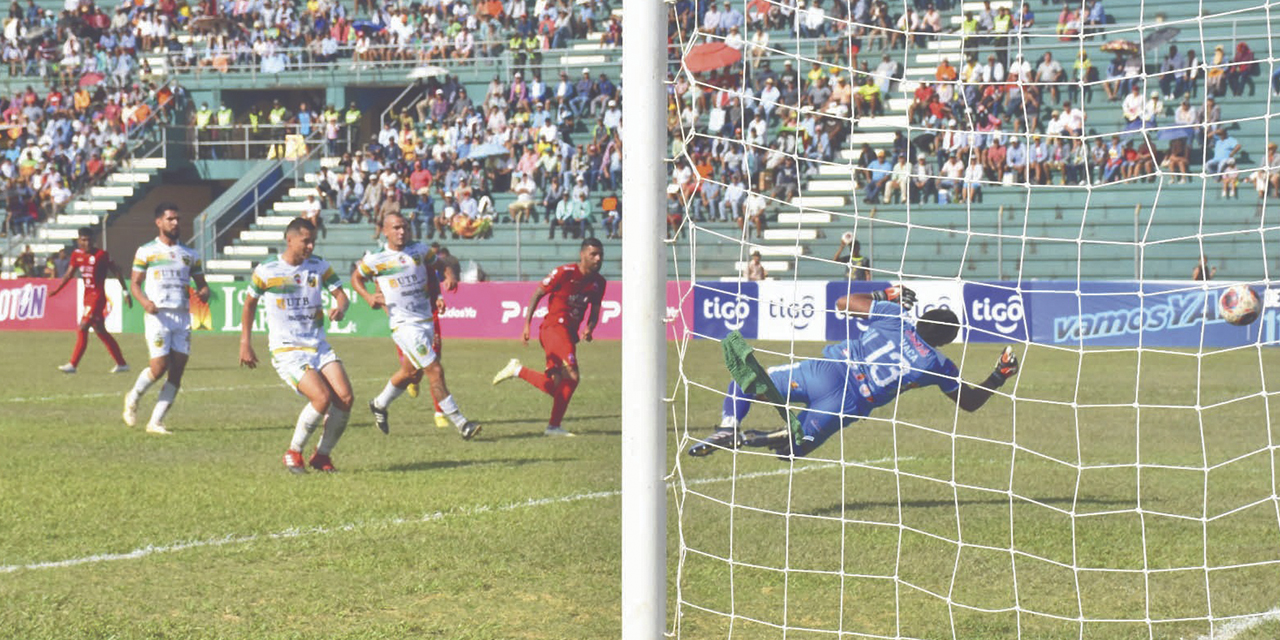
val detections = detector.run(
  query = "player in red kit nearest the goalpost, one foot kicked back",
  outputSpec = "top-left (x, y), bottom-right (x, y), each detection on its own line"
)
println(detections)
top-left (493, 238), bottom-right (604, 435)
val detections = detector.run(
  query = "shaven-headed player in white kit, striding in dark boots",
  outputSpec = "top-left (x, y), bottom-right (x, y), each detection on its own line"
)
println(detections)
top-left (351, 214), bottom-right (480, 440)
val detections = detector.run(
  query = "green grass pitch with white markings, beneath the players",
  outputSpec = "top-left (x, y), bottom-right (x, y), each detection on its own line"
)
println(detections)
top-left (0, 334), bottom-right (1280, 640)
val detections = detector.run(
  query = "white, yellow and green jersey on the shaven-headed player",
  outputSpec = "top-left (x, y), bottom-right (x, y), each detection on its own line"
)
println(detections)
top-left (356, 242), bottom-right (436, 329)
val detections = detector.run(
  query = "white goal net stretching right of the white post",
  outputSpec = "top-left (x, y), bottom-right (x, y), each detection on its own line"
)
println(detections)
top-left (667, 0), bottom-right (1280, 639)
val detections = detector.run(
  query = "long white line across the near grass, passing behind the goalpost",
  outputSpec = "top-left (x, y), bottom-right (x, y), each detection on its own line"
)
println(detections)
top-left (0, 458), bottom-right (885, 573)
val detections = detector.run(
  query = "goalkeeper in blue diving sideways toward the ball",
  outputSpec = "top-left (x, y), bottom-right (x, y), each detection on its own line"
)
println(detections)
top-left (689, 287), bottom-right (1018, 458)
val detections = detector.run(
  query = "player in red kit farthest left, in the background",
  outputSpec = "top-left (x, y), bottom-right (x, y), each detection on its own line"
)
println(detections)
top-left (50, 227), bottom-right (133, 374)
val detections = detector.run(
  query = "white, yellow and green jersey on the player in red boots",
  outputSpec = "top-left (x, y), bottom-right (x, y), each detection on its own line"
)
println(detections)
top-left (248, 256), bottom-right (342, 353)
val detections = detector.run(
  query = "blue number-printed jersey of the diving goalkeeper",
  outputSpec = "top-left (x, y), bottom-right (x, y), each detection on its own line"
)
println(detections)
top-left (823, 302), bottom-right (960, 411)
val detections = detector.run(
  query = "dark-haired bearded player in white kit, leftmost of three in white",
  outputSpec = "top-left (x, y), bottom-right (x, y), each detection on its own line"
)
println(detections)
top-left (124, 202), bottom-right (209, 435)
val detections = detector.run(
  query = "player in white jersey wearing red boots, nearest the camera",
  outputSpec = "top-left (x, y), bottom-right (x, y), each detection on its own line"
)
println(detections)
top-left (239, 218), bottom-right (353, 474)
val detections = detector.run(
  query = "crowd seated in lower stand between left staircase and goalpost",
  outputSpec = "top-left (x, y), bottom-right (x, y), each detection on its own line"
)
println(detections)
top-left (309, 69), bottom-right (622, 238)
